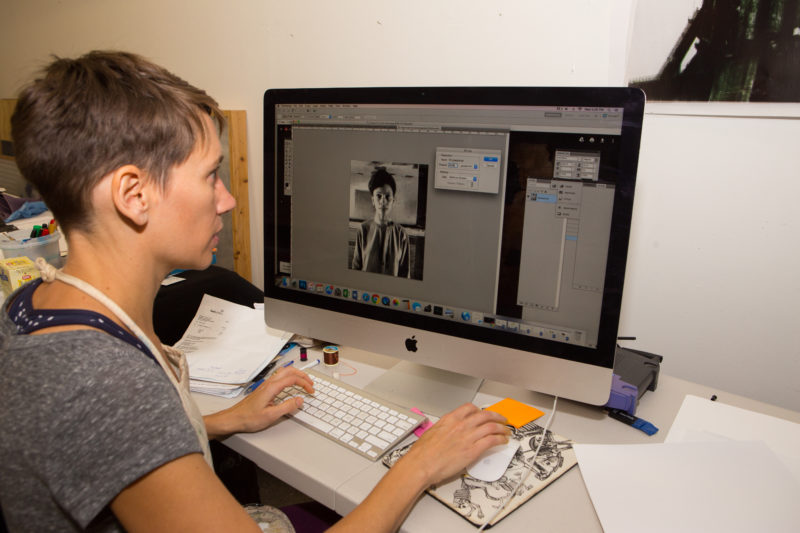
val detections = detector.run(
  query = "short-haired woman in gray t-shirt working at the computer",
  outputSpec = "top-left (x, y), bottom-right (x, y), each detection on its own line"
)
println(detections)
top-left (0, 52), bottom-right (507, 532)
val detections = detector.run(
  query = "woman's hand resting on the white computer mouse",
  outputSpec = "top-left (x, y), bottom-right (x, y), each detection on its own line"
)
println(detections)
top-left (406, 403), bottom-right (511, 484)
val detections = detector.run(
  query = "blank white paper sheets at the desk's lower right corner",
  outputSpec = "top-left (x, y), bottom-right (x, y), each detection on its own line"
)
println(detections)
top-left (575, 396), bottom-right (800, 533)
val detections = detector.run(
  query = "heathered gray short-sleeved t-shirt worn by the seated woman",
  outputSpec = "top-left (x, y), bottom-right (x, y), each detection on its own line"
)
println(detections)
top-left (0, 302), bottom-right (202, 532)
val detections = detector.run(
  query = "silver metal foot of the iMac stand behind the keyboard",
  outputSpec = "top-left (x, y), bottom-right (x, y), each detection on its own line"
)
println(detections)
top-left (364, 361), bottom-right (483, 417)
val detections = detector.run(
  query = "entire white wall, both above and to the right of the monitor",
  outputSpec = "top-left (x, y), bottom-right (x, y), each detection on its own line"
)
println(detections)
top-left (0, 0), bottom-right (800, 409)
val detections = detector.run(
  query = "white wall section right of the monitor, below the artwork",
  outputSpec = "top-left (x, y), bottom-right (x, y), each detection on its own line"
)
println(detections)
top-left (620, 104), bottom-right (800, 409)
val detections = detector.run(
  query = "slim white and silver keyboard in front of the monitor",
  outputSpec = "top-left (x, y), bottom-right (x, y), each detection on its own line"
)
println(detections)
top-left (275, 370), bottom-right (425, 461)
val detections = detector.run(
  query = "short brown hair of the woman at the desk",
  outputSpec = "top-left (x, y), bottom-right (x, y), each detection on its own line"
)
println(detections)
top-left (11, 51), bottom-right (225, 230)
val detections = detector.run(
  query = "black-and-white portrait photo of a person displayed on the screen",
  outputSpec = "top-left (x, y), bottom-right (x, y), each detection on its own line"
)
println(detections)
top-left (348, 161), bottom-right (428, 280)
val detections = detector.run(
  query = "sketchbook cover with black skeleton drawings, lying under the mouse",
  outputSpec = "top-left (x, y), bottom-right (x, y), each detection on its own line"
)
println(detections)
top-left (384, 422), bottom-right (577, 525)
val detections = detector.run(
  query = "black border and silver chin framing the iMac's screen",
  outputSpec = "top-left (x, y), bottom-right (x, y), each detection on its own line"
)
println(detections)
top-left (264, 87), bottom-right (644, 405)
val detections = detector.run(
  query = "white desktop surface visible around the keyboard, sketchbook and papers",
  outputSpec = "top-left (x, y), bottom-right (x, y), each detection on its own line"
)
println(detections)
top-left (195, 348), bottom-right (800, 533)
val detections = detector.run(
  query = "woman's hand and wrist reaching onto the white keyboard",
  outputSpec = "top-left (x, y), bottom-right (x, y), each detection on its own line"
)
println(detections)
top-left (204, 368), bottom-right (314, 438)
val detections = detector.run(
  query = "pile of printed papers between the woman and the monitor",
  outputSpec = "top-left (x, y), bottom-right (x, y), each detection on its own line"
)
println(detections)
top-left (175, 294), bottom-right (292, 397)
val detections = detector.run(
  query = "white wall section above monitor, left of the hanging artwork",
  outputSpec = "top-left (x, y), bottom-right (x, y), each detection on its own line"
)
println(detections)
top-left (0, 0), bottom-right (631, 286)
